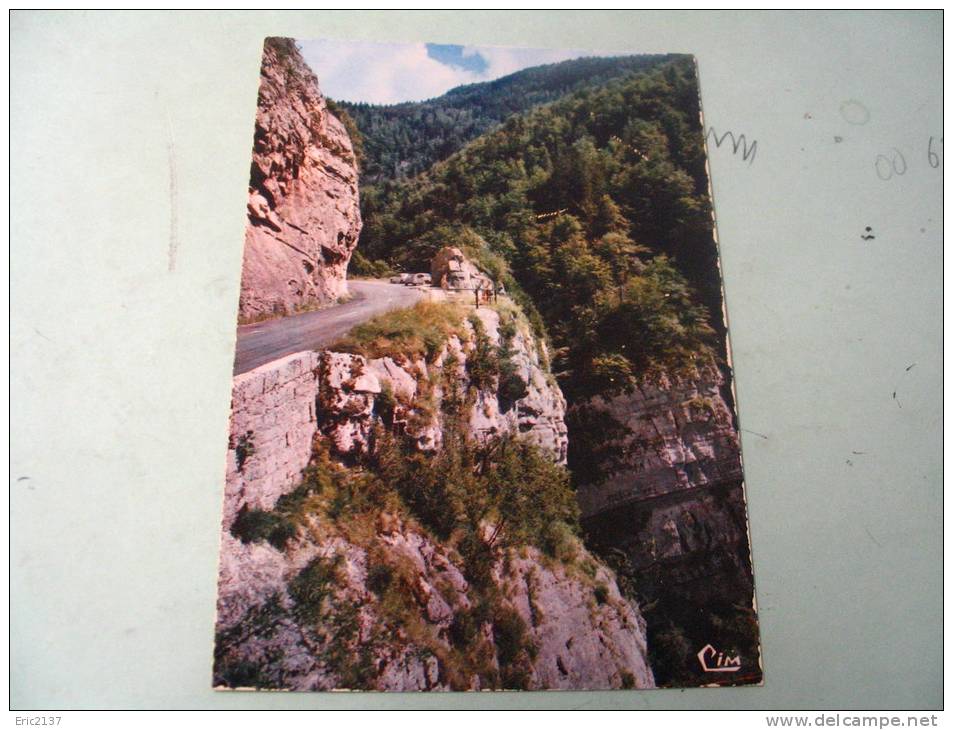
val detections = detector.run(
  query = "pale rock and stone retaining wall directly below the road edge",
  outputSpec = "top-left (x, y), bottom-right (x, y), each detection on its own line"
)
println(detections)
top-left (224, 307), bottom-right (568, 528)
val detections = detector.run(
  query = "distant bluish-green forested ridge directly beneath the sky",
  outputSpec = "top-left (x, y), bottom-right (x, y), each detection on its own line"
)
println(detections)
top-left (335, 56), bottom-right (673, 183)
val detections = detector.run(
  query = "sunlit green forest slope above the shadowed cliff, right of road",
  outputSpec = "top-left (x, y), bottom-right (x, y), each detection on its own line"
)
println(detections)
top-left (348, 58), bottom-right (721, 410)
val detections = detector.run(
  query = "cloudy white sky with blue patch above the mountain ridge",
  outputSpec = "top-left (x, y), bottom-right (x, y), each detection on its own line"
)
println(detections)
top-left (298, 40), bottom-right (592, 104)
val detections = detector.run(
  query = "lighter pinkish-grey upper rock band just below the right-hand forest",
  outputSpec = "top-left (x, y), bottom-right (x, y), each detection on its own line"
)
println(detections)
top-left (577, 363), bottom-right (741, 517)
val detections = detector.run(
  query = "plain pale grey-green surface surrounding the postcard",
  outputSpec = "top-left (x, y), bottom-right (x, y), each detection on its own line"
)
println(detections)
top-left (10, 11), bottom-right (942, 710)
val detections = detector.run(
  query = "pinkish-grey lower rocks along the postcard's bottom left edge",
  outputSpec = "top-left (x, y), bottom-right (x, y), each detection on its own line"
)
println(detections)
top-left (215, 518), bottom-right (655, 691)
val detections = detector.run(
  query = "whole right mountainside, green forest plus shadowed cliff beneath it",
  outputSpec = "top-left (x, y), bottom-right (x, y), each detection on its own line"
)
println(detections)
top-left (348, 57), bottom-right (761, 686)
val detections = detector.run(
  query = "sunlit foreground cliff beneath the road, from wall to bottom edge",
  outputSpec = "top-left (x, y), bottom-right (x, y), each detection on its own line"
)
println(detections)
top-left (215, 298), bottom-right (654, 690)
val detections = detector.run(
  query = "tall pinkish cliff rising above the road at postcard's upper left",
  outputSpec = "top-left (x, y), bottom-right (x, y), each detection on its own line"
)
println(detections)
top-left (239, 38), bottom-right (361, 321)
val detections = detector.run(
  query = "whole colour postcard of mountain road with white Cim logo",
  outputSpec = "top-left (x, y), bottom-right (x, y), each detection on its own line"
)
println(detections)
top-left (213, 38), bottom-right (761, 691)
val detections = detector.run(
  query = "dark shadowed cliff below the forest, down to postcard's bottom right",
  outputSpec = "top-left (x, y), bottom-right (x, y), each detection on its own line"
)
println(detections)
top-left (570, 362), bottom-right (761, 686)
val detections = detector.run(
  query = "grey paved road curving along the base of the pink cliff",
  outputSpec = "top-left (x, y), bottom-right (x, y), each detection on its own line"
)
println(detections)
top-left (232, 280), bottom-right (422, 375)
